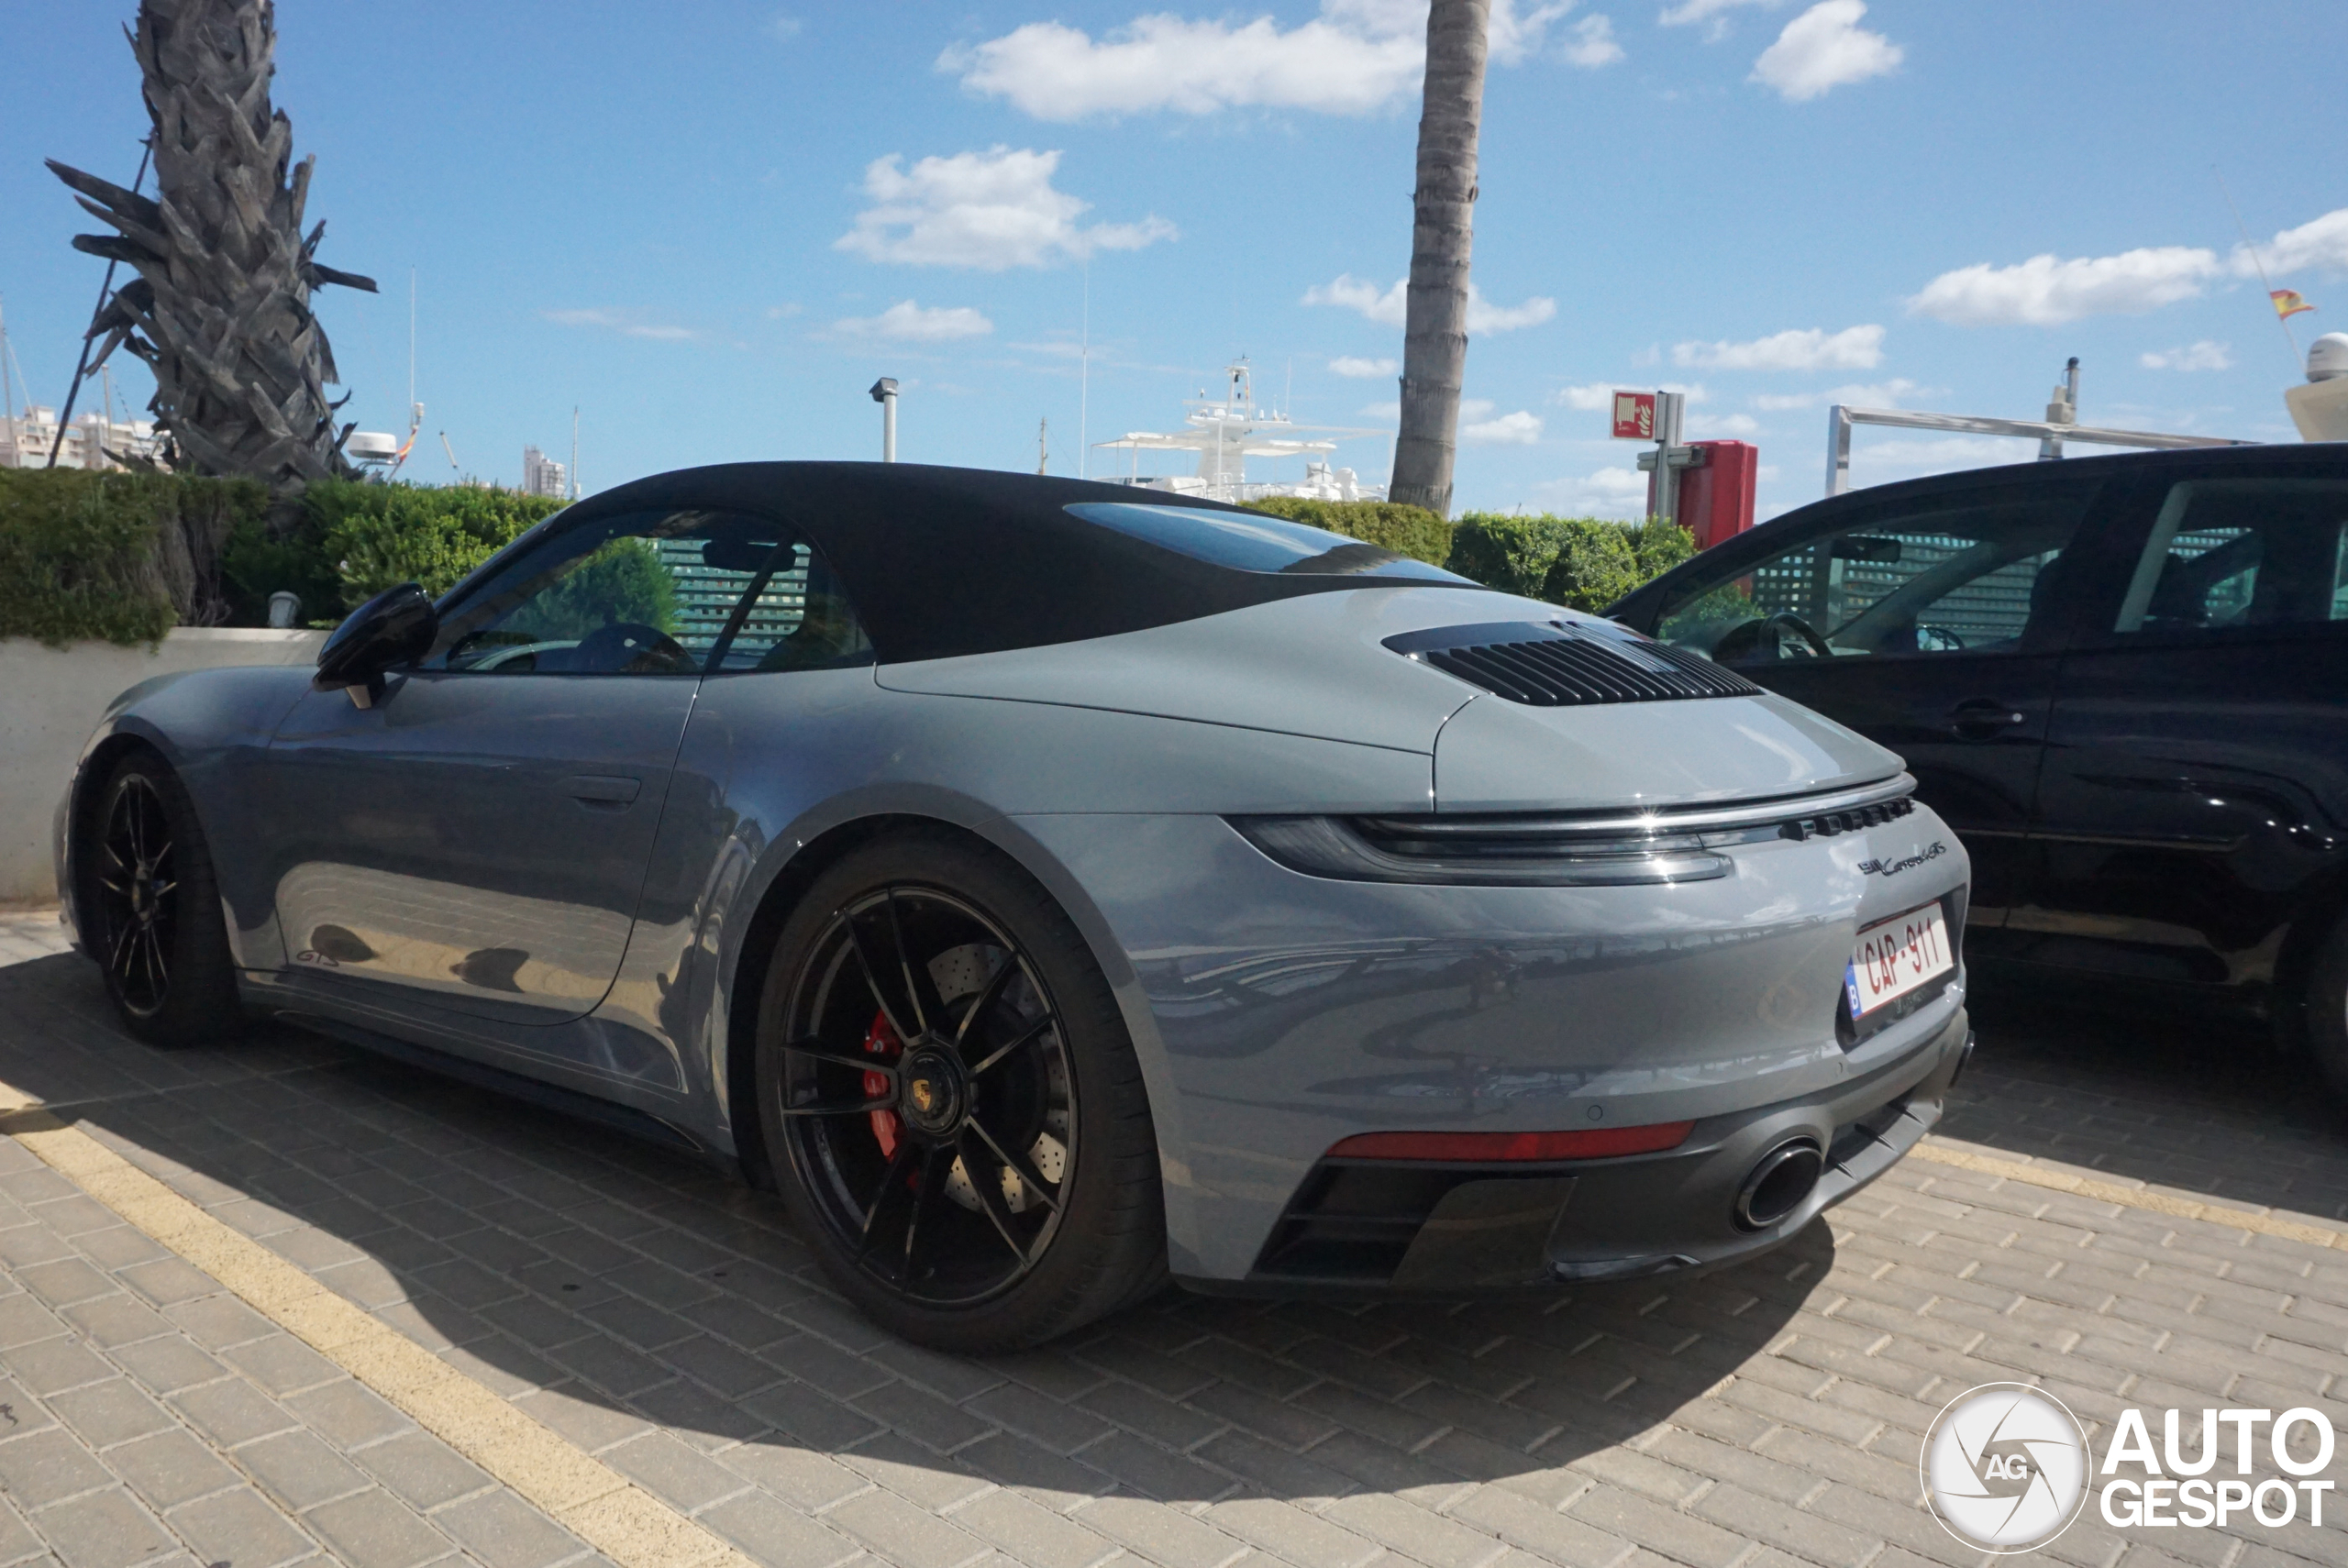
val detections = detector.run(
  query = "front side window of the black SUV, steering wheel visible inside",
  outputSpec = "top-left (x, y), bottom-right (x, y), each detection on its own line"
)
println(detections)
top-left (1656, 483), bottom-right (2095, 664)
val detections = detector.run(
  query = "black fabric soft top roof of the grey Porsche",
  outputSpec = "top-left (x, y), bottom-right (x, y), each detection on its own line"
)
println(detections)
top-left (547, 462), bottom-right (1465, 664)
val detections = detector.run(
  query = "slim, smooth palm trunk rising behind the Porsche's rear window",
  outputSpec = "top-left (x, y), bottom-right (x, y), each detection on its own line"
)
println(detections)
top-left (1388, 0), bottom-right (1491, 516)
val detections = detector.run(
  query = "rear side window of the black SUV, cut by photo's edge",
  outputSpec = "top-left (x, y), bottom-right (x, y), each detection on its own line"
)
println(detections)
top-left (2110, 477), bottom-right (2348, 636)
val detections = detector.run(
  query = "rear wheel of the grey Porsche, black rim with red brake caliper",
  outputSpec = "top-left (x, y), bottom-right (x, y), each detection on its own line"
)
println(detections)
top-left (756, 834), bottom-right (1165, 1354)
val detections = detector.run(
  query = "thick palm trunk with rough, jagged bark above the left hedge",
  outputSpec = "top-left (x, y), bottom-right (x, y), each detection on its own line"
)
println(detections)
top-left (50, 0), bottom-right (376, 500)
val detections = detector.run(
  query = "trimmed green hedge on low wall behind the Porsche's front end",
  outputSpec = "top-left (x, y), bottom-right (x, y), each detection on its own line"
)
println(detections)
top-left (0, 469), bottom-right (561, 646)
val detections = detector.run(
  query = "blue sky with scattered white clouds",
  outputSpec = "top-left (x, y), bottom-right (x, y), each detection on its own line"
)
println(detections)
top-left (0, 0), bottom-right (2348, 514)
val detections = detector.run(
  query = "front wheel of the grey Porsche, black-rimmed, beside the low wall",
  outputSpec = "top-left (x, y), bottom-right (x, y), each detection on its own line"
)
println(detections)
top-left (75, 751), bottom-right (242, 1047)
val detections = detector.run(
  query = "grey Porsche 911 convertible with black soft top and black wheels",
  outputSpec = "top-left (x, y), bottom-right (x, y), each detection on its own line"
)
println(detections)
top-left (56, 462), bottom-right (1970, 1350)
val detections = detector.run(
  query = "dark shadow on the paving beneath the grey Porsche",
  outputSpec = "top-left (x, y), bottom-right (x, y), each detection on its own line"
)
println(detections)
top-left (0, 955), bottom-right (1822, 1505)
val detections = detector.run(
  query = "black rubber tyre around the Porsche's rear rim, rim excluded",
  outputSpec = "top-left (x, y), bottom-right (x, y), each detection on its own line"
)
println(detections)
top-left (756, 835), bottom-right (1162, 1352)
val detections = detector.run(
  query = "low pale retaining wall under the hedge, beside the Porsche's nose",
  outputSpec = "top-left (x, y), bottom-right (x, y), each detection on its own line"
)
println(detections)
top-left (0, 626), bottom-right (327, 904)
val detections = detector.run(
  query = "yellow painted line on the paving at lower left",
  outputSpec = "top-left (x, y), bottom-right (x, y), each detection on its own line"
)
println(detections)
top-left (0, 1103), bottom-right (749, 1568)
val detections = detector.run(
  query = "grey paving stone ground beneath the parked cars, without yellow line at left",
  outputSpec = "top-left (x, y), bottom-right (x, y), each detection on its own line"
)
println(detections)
top-left (0, 915), bottom-right (2348, 1568)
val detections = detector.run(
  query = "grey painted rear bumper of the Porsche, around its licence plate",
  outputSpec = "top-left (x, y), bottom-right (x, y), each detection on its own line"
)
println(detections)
top-left (1014, 808), bottom-right (1967, 1284)
